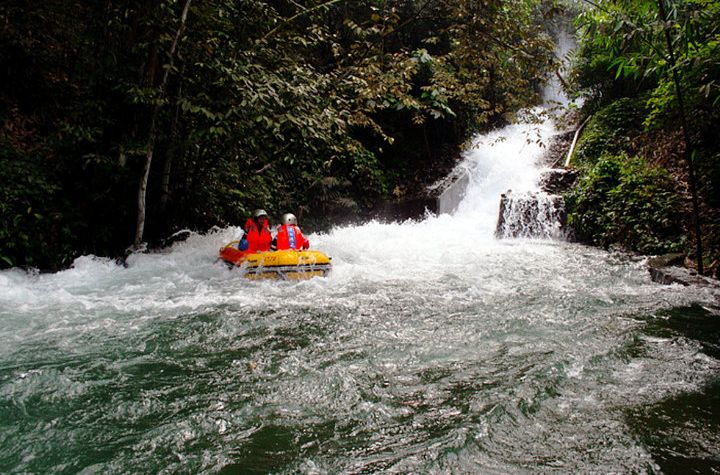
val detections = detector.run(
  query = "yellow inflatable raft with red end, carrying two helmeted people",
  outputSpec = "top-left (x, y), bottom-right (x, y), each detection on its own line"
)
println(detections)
top-left (220, 241), bottom-right (332, 280)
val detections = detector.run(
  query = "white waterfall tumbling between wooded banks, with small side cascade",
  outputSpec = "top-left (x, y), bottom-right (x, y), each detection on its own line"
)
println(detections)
top-left (436, 27), bottom-right (574, 239)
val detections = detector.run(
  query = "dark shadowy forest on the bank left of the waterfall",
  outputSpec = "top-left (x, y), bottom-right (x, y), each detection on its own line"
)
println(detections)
top-left (0, 0), bottom-right (553, 267)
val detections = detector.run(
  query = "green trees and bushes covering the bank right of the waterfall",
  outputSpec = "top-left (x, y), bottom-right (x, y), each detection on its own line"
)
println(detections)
top-left (570, 0), bottom-right (720, 270)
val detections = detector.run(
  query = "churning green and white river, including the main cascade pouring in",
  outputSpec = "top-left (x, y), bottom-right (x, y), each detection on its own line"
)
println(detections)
top-left (0, 107), bottom-right (720, 473)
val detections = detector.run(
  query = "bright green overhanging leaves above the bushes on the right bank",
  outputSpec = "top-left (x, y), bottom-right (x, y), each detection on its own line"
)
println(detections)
top-left (575, 0), bottom-right (720, 115)
